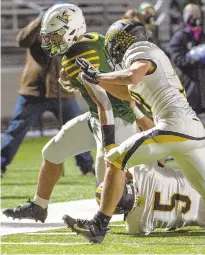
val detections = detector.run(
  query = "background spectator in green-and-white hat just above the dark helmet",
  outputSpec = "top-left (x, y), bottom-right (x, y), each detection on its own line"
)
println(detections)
top-left (138, 2), bottom-right (160, 44)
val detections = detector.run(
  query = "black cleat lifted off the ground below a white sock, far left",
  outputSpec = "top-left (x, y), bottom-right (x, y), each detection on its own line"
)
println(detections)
top-left (2, 200), bottom-right (47, 223)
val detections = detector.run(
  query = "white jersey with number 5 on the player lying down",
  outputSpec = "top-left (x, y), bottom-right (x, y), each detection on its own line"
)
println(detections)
top-left (127, 164), bottom-right (205, 234)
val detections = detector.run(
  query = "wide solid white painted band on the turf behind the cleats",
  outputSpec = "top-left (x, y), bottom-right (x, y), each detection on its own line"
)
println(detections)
top-left (0, 199), bottom-right (123, 236)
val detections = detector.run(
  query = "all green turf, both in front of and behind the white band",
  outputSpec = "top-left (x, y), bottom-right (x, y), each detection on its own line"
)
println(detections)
top-left (1, 138), bottom-right (205, 254)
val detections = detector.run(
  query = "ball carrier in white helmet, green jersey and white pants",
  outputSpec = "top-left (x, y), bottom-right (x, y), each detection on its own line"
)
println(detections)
top-left (4, 4), bottom-right (153, 222)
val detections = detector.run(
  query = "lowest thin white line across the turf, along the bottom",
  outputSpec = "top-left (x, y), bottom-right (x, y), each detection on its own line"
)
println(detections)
top-left (0, 242), bottom-right (205, 246)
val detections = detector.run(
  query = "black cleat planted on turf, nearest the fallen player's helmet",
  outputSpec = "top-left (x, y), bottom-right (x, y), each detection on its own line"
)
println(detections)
top-left (63, 215), bottom-right (108, 243)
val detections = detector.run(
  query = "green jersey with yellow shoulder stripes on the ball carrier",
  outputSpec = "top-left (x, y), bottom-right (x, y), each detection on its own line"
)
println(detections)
top-left (62, 33), bottom-right (136, 123)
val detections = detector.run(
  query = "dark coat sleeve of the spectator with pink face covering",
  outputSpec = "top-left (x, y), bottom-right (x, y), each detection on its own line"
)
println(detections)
top-left (168, 32), bottom-right (192, 68)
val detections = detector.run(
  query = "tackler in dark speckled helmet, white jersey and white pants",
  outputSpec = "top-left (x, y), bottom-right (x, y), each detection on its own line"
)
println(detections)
top-left (65, 20), bottom-right (205, 243)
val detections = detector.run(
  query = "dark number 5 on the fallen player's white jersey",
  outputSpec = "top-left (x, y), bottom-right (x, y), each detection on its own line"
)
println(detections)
top-left (154, 191), bottom-right (191, 214)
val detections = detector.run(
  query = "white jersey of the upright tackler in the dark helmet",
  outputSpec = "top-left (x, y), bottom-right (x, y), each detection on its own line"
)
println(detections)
top-left (122, 41), bottom-right (195, 119)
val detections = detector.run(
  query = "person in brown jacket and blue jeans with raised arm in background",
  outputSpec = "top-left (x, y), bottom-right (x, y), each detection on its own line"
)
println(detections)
top-left (1, 12), bottom-right (94, 176)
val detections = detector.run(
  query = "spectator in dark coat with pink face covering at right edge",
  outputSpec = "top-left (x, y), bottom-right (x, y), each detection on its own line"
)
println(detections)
top-left (169, 4), bottom-right (205, 114)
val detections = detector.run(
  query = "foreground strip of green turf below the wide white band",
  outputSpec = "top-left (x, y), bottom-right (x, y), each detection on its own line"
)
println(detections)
top-left (2, 224), bottom-right (205, 254)
